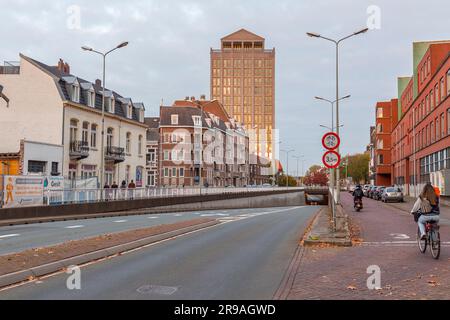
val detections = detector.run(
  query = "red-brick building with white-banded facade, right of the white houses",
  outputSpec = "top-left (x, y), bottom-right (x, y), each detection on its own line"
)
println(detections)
top-left (159, 97), bottom-right (249, 187)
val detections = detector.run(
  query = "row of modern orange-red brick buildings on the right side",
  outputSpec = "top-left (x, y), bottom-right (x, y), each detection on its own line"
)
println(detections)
top-left (370, 41), bottom-right (450, 196)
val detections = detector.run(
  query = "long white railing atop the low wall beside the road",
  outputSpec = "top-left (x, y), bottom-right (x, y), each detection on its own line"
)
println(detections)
top-left (44, 187), bottom-right (304, 205)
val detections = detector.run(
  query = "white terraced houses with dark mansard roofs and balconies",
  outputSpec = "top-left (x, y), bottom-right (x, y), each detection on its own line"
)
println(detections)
top-left (0, 54), bottom-right (147, 187)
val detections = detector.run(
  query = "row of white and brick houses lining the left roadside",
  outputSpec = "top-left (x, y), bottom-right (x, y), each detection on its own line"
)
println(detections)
top-left (0, 54), bottom-right (274, 187)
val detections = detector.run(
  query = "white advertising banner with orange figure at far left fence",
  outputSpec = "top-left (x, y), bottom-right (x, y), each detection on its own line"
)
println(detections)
top-left (3, 176), bottom-right (44, 208)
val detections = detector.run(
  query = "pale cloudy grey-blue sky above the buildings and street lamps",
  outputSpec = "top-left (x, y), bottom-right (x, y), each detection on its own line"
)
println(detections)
top-left (0, 0), bottom-right (450, 174)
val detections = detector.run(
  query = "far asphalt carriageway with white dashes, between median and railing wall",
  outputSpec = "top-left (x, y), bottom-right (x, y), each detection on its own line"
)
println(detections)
top-left (0, 208), bottom-right (282, 255)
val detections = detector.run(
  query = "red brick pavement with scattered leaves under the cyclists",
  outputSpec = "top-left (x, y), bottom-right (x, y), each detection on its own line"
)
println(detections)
top-left (287, 193), bottom-right (450, 299)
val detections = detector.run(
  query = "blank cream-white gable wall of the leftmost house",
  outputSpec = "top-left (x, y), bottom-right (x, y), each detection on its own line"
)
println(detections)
top-left (0, 58), bottom-right (63, 153)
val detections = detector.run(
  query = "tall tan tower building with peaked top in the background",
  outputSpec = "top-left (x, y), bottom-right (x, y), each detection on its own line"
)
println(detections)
top-left (210, 29), bottom-right (275, 159)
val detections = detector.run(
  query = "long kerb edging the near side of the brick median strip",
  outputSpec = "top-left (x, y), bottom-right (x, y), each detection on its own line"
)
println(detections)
top-left (0, 220), bottom-right (220, 288)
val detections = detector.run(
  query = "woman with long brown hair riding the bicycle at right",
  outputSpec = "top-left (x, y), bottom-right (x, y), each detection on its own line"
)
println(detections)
top-left (411, 183), bottom-right (439, 240)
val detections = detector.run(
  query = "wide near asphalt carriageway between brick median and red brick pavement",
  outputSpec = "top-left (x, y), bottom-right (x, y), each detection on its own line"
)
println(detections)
top-left (0, 207), bottom-right (317, 299)
